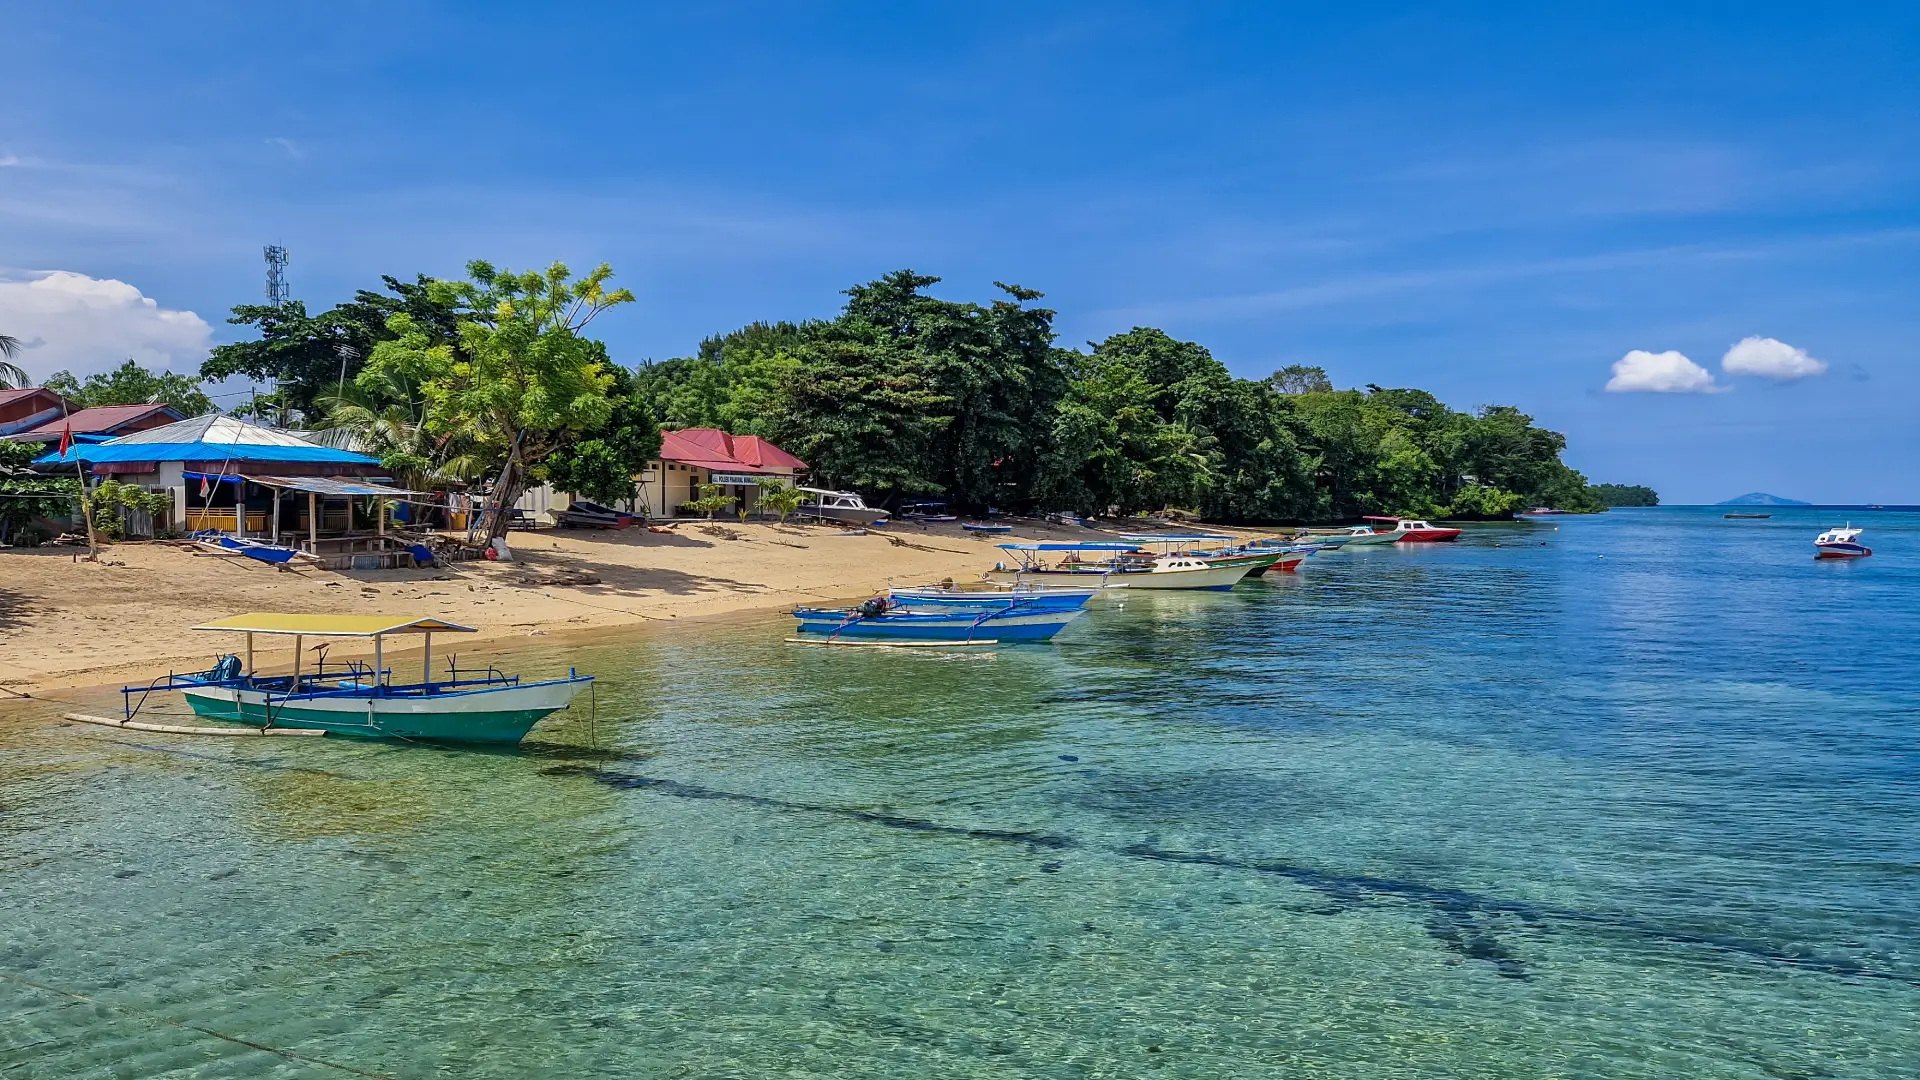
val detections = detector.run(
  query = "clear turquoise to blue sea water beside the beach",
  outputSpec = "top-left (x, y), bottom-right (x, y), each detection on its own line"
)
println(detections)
top-left (0, 509), bottom-right (1920, 1080)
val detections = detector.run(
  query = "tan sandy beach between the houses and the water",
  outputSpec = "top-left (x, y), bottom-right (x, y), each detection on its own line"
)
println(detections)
top-left (0, 521), bottom-right (1198, 692)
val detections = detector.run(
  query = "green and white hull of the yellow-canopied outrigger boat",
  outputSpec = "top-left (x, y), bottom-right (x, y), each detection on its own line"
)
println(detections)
top-left (184, 678), bottom-right (591, 744)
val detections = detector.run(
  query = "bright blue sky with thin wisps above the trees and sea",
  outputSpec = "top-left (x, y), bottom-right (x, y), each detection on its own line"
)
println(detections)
top-left (0, 4), bottom-right (1920, 502)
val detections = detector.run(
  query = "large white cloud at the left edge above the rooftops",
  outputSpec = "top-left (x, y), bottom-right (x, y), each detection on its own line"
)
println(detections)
top-left (0, 271), bottom-right (213, 380)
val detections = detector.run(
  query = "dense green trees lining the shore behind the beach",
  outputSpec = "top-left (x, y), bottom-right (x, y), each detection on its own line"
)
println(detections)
top-left (202, 263), bottom-right (1635, 523)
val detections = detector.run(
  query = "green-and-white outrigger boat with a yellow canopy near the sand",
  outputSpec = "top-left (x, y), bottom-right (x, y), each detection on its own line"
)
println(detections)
top-left (121, 613), bottom-right (593, 744)
